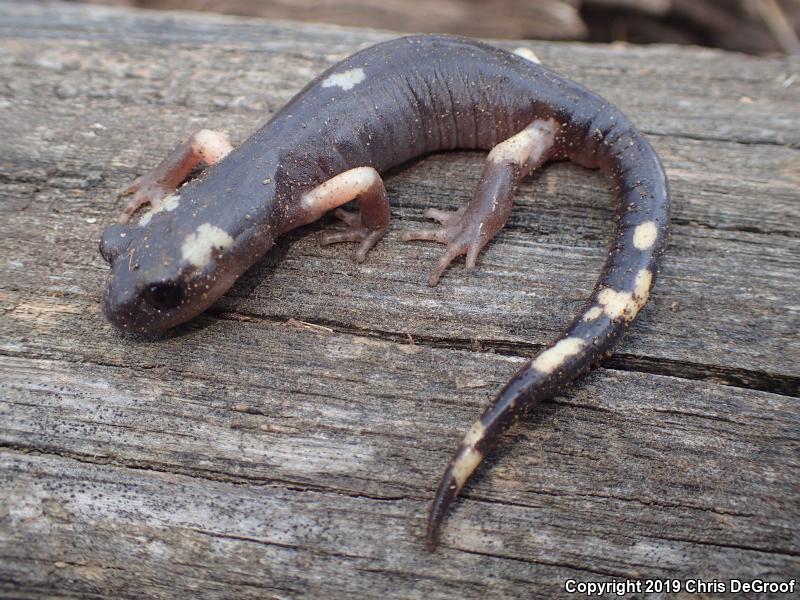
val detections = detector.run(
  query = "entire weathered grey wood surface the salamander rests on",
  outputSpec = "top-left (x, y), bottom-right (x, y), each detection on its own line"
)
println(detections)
top-left (0, 2), bottom-right (800, 598)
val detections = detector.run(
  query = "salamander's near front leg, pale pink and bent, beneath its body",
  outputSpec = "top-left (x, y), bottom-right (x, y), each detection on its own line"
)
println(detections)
top-left (302, 167), bottom-right (390, 262)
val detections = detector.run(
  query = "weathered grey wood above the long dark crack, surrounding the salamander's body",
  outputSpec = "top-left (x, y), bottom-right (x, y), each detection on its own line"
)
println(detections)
top-left (0, 1), bottom-right (800, 391)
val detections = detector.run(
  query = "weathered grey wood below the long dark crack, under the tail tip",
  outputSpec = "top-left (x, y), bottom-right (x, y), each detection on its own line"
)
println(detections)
top-left (2, 328), bottom-right (800, 597)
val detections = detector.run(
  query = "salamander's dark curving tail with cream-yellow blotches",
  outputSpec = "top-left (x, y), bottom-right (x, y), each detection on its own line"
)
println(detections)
top-left (427, 129), bottom-right (669, 548)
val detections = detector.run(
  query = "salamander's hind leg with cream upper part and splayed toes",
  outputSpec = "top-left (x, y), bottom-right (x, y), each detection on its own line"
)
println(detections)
top-left (401, 119), bottom-right (558, 286)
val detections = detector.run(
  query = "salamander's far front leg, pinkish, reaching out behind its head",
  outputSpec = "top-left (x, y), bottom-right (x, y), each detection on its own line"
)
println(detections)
top-left (119, 129), bottom-right (233, 223)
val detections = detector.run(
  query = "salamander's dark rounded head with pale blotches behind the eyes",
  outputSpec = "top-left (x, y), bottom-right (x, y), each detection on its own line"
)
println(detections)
top-left (100, 188), bottom-right (271, 333)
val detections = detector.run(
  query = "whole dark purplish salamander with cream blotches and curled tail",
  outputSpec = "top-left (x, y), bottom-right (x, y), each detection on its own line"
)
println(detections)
top-left (100, 35), bottom-right (670, 548)
